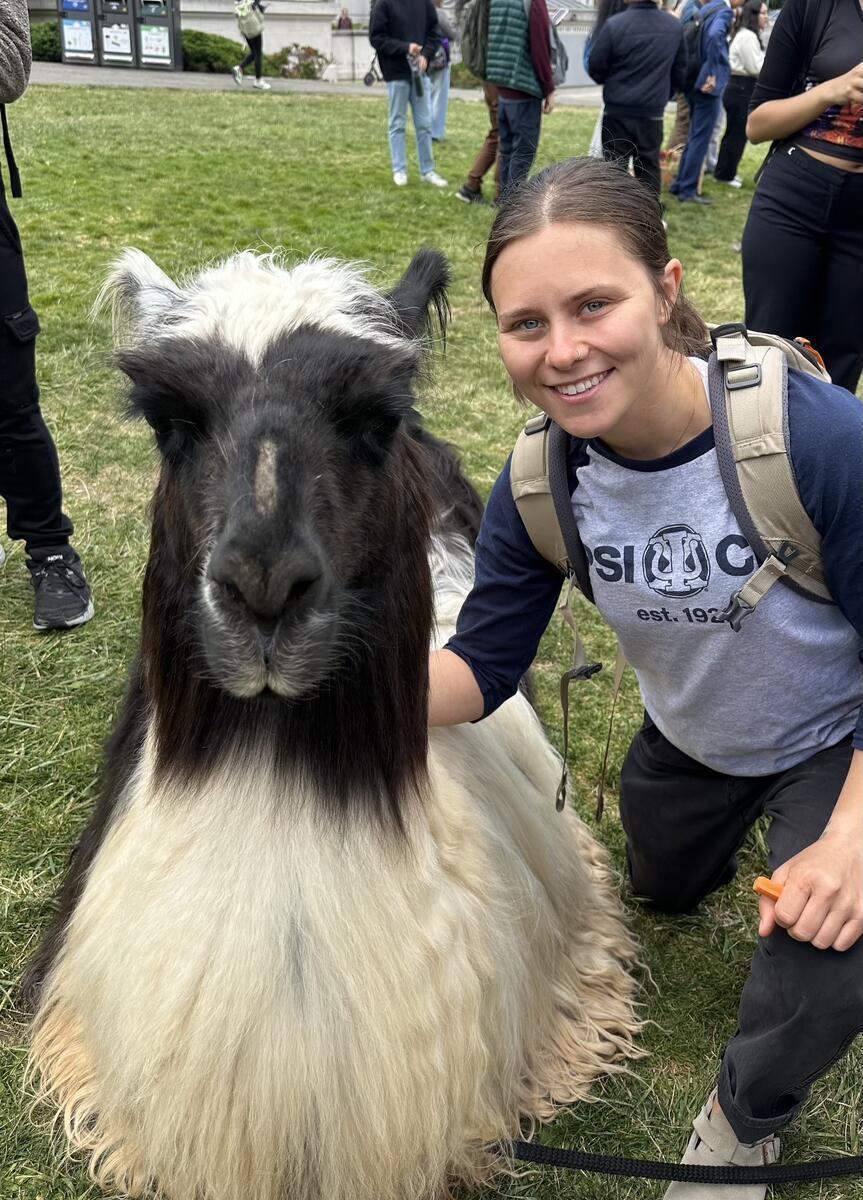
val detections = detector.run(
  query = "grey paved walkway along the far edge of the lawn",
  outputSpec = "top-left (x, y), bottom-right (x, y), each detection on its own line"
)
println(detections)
top-left (30, 62), bottom-right (603, 108)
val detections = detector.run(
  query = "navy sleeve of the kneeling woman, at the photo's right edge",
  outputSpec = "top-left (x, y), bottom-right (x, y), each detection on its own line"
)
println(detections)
top-left (789, 371), bottom-right (863, 750)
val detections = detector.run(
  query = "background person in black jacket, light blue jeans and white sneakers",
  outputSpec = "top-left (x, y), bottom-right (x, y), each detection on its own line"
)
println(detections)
top-left (368, 0), bottom-right (447, 187)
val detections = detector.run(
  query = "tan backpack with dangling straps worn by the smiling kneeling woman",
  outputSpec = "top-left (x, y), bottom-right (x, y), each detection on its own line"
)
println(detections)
top-left (510, 324), bottom-right (832, 818)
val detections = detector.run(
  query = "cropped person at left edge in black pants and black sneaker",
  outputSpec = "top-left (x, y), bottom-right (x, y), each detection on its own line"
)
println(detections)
top-left (0, 0), bottom-right (94, 631)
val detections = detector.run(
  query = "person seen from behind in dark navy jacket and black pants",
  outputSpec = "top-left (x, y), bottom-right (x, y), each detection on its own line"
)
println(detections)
top-left (588, 0), bottom-right (687, 193)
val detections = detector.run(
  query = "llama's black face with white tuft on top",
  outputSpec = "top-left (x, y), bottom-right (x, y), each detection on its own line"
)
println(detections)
top-left (109, 256), bottom-right (451, 698)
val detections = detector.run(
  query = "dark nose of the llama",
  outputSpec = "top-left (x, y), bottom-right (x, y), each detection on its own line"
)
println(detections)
top-left (208, 544), bottom-right (324, 624)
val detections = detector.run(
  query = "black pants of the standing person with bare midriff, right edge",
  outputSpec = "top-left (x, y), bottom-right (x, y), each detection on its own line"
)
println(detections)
top-left (743, 146), bottom-right (863, 391)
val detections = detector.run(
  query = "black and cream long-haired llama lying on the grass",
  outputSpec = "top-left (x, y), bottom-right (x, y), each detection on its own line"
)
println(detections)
top-left (24, 251), bottom-right (639, 1200)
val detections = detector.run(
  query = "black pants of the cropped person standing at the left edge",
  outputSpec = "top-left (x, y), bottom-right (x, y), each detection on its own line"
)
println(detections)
top-left (0, 184), bottom-right (72, 557)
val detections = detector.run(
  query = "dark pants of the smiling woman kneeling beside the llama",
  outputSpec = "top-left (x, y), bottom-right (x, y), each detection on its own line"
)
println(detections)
top-left (621, 718), bottom-right (863, 1142)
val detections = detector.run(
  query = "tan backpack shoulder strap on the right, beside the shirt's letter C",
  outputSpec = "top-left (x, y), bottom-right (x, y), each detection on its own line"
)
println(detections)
top-left (708, 326), bottom-right (831, 630)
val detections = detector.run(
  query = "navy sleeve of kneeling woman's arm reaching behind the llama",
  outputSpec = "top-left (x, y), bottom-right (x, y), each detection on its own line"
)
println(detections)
top-left (444, 461), bottom-right (563, 716)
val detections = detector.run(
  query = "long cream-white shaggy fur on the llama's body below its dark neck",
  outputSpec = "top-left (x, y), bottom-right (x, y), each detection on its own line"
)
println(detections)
top-left (30, 248), bottom-right (639, 1200)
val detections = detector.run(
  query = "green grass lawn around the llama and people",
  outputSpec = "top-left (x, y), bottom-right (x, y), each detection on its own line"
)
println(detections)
top-left (0, 88), bottom-right (863, 1200)
